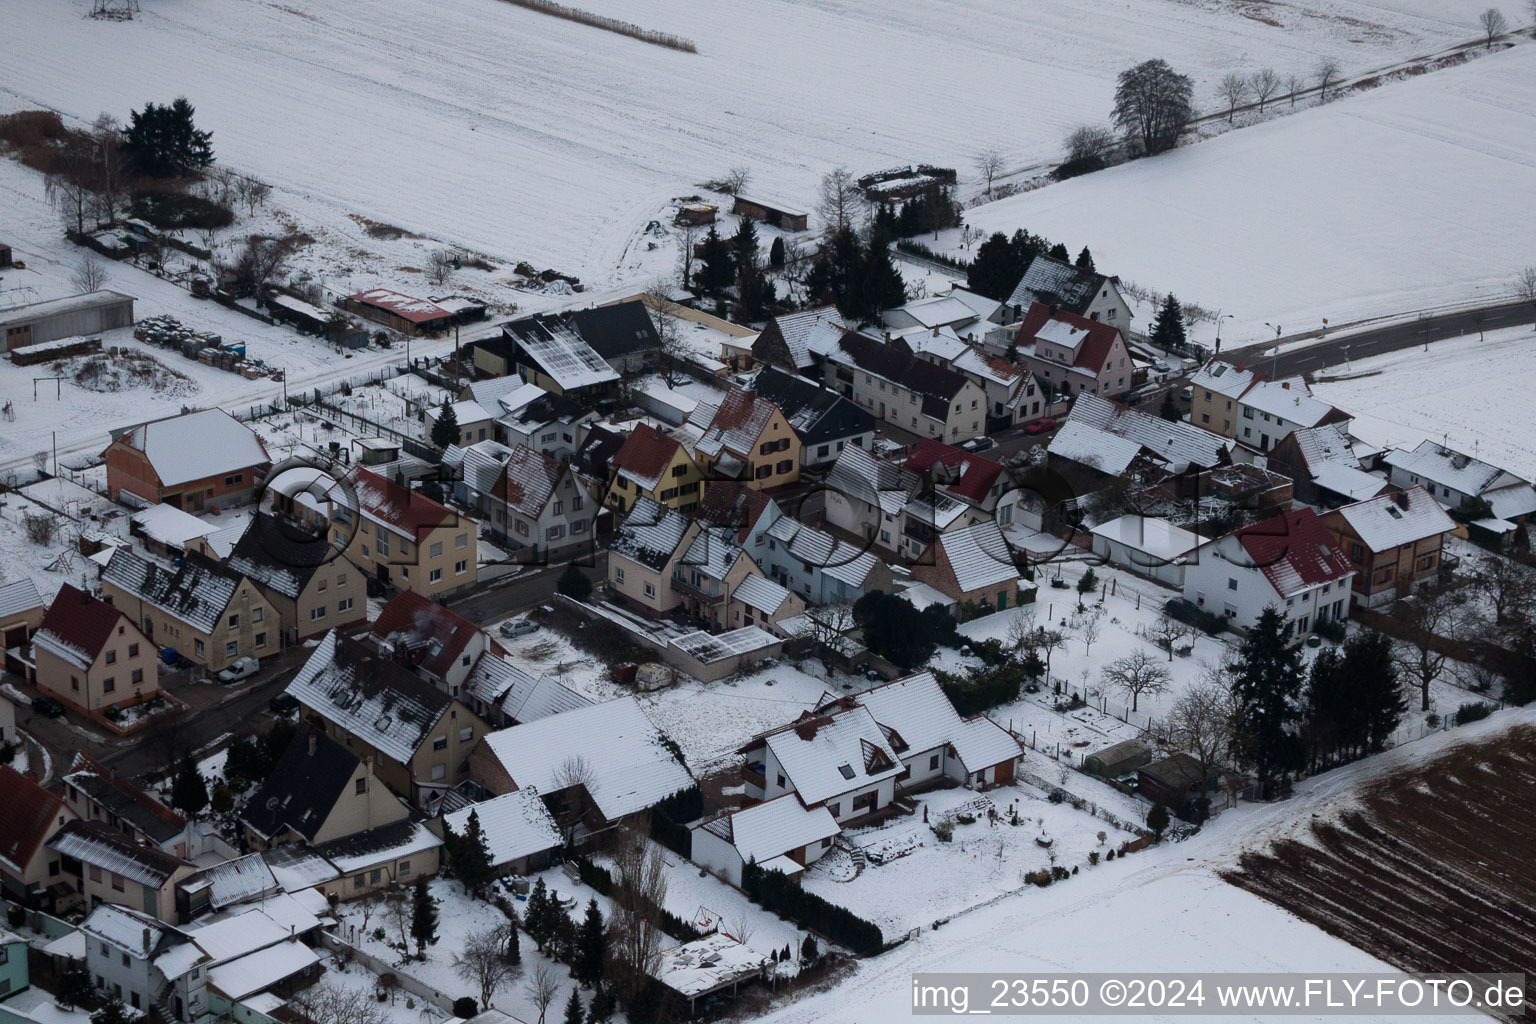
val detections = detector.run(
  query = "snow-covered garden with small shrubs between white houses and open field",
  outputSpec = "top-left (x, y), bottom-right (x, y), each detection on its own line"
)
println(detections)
top-left (802, 783), bottom-right (1135, 938)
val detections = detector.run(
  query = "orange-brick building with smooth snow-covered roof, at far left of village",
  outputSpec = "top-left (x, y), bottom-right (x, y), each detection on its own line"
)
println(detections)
top-left (101, 408), bottom-right (272, 511)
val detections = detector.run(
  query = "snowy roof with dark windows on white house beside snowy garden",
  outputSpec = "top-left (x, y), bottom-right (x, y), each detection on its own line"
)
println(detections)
top-left (753, 706), bottom-right (902, 804)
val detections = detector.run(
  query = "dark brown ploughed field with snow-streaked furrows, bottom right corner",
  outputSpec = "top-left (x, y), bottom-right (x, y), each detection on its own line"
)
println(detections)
top-left (1224, 726), bottom-right (1536, 1019)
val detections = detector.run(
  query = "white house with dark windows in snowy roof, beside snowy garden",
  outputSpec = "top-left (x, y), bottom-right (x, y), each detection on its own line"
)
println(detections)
top-left (739, 705), bottom-right (906, 826)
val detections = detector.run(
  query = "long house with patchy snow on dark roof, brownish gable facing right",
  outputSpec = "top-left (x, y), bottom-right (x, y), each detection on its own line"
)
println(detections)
top-left (287, 631), bottom-right (488, 806)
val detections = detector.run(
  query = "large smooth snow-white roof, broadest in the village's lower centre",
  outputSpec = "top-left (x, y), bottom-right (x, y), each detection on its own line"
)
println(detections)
top-left (484, 697), bottom-right (693, 821)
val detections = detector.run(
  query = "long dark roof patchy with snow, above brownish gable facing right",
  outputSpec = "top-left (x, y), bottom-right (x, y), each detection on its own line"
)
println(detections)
top-left (287, 629), bottom-right (453, 763)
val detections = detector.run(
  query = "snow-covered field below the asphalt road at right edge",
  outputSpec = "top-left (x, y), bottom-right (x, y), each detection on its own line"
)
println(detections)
top-left (1316, 323), bottom-right (1536, 479)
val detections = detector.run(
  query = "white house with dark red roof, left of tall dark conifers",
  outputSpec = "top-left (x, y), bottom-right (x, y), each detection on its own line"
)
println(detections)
top-left (1184, 507), bottom-right (1355, 640)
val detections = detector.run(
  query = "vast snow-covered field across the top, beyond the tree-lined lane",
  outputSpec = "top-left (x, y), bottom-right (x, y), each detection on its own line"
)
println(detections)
top-left (0, 0), bottom-right (1485, 291)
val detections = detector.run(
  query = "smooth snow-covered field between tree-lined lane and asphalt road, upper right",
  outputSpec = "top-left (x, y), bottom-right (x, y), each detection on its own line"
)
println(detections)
top-left (951, 43), bottom-right (1536, 347)
